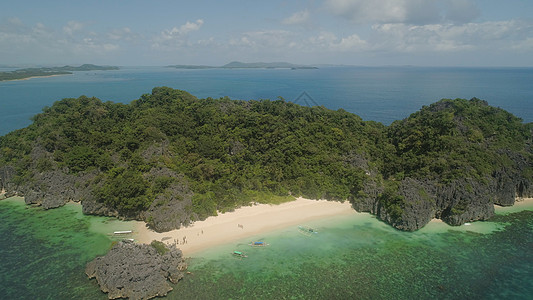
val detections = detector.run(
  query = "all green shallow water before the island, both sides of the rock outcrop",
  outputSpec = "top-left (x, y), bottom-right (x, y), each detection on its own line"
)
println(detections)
top-left (0, 200), bottom-right (533, 299)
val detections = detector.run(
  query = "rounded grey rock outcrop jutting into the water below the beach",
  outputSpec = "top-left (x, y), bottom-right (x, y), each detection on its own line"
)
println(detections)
top-left (85, 241), bottom-right (187, 299)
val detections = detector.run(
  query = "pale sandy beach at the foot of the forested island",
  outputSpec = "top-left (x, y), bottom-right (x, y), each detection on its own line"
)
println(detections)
top-left (134, 198), bottom-right (358, 256)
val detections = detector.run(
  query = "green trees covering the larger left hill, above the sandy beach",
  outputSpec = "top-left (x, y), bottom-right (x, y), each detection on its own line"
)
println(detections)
top-left (0, 87), bottom-right (386, 218)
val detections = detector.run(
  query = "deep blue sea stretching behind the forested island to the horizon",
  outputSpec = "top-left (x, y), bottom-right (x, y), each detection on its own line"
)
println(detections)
top-left (0, 67), bottom-right (533, 135)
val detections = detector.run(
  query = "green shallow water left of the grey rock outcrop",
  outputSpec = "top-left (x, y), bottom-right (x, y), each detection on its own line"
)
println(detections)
top-left (0, 198), bottom-right (132, 299)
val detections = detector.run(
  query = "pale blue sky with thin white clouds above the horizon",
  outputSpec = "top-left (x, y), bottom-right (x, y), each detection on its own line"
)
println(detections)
top-left (0, 0), bottom-right (533, 67)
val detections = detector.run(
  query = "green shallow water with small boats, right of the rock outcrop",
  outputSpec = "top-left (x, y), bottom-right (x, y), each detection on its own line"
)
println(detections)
top-left (170, 206), bottom-right (533, 299)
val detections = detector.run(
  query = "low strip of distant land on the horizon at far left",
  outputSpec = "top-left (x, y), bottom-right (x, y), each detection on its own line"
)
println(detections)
top-left (0, 64), bottom-right (119, 81)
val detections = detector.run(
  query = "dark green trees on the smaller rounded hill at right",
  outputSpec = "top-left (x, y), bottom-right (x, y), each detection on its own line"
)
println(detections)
top-left (384, 98), bottom-right (531, 183)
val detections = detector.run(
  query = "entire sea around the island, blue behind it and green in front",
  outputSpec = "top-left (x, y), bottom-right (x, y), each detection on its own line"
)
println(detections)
top-left (0, 67), bottom-right (533, 300)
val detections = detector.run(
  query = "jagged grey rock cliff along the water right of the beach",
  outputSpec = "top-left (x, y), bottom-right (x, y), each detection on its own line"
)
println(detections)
top-left (352, 168), bottom-right (533, 231)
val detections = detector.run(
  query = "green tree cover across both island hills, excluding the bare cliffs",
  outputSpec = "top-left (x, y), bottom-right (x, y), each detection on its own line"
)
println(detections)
top-left (0, 87), bottom-right (533, 229)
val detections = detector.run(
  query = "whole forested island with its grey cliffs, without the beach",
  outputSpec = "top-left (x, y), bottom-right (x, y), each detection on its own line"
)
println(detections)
top-left (0, 87), bottom-right (533, 231)
